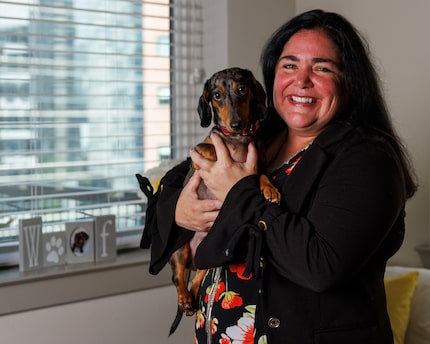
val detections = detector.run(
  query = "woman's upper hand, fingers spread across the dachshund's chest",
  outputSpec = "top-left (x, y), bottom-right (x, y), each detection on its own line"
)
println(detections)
top-left (190, 133), bottom-right (258, 201)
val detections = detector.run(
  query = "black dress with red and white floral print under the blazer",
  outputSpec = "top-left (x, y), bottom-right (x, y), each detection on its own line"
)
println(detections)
top-left (194, 145), bottom-right (309, 344)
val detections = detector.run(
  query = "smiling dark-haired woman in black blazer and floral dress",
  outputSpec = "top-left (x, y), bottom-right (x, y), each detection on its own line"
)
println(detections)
top-left (148, 10), bottom-right (416, 344)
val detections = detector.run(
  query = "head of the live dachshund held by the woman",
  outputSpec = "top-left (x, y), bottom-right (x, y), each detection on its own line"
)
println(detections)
top-left (197, 68), bottom-right (266, 136)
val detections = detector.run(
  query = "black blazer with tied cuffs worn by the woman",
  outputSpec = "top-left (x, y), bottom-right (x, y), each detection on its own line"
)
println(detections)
top-left (146, 124), bottom-right (406, 344)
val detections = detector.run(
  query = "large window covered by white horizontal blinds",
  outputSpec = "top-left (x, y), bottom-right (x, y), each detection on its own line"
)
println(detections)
top-left (0, 0), bottom-right (202, 264)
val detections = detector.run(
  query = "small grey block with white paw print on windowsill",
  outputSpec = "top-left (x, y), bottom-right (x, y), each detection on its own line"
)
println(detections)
top-left (43, 232), bottom-right (67, 267)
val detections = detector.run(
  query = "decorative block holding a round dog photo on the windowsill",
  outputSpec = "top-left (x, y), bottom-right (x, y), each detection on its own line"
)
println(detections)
top-left (66, 219), bottom-right (94, 264)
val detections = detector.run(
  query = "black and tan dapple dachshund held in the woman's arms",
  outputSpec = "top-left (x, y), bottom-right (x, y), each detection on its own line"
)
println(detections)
top-left (169, 68), bottom-right (280, 334)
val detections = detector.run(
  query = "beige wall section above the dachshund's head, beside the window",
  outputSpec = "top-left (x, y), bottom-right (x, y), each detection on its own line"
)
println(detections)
top-left (203, 0), bottom-right (295, 81)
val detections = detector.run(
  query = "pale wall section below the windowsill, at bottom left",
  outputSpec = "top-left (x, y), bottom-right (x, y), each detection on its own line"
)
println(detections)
top-left (0, 286), bottom-right (193, 344)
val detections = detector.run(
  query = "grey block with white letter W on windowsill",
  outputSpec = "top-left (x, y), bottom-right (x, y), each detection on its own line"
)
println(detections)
top-left (19, 217), bottom-right (43, 271)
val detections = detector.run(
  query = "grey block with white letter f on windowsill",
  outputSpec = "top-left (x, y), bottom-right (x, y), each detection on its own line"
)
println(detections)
top-left (94, 215), bottom-right (116, 263)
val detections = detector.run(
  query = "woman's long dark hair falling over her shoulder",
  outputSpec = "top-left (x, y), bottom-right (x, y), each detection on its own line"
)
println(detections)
top-left (261, 10), bottom-right (417, 197)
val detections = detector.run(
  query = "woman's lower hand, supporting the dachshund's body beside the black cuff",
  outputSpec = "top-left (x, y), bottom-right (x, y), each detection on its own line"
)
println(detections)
top-left (175, 171), bottom-right (222, 232)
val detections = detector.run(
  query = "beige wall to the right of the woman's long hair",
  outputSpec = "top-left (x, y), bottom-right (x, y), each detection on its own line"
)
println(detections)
top-left (296, 0), bottom-right (430, 266)
